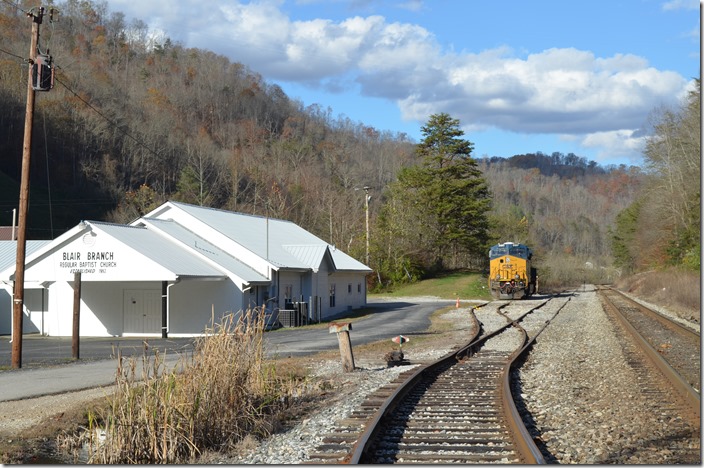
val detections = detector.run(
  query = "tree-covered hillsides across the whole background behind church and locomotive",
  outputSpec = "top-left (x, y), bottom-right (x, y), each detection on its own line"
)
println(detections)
top-left (0, 0), bottom-right (700, 287)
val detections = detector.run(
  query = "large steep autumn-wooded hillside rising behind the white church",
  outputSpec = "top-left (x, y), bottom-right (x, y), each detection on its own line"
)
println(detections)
top-left (0, 1), bottom-right (412, 248)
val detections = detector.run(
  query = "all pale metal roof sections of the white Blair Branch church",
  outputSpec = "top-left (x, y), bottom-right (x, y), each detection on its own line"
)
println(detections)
top-left (0, 201), bottom-right (372, 283)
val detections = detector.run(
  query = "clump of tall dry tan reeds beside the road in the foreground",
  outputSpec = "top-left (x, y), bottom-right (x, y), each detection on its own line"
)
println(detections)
top-left (60, 311), bottom-right (310, 464)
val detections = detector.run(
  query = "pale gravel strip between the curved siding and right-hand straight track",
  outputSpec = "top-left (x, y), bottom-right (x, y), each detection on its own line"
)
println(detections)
top-left (514, 288), bottom-right (701, 465)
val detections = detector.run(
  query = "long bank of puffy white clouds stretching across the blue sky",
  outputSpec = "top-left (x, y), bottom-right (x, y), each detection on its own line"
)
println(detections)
top-left (102, 0), bottom-right (692, 163)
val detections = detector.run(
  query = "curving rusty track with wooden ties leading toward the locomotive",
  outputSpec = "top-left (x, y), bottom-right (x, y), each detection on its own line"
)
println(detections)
top-left (310, 299), bottom-right (569, 464)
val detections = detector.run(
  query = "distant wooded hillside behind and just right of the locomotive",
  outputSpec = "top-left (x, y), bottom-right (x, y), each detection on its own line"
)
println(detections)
top-left (480, 153), bottom-right (644, 281)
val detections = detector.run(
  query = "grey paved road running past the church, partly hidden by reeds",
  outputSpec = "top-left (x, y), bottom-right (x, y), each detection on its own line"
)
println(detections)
top-left (0, 298), bottom-right (460, 401)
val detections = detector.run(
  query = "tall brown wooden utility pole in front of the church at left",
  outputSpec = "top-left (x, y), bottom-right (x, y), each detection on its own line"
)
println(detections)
top-left (12, 7), bottom-right (44, 369)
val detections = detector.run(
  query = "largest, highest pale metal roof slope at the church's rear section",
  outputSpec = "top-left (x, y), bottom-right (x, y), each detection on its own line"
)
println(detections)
top-left (168, 201), bottom-right (372, 271)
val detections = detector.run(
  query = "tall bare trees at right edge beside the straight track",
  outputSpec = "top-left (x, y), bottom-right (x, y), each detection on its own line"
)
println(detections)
top-left (612, 79), bottom-right (702, 273)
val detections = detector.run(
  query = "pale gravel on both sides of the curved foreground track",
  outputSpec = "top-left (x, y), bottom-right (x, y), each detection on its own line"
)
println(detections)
top-left (219, 286), bottom-right (701, 464)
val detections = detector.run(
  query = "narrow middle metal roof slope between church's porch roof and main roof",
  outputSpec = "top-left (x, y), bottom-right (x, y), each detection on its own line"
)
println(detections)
top-left (141, 218), bottom-right (269, 283)
